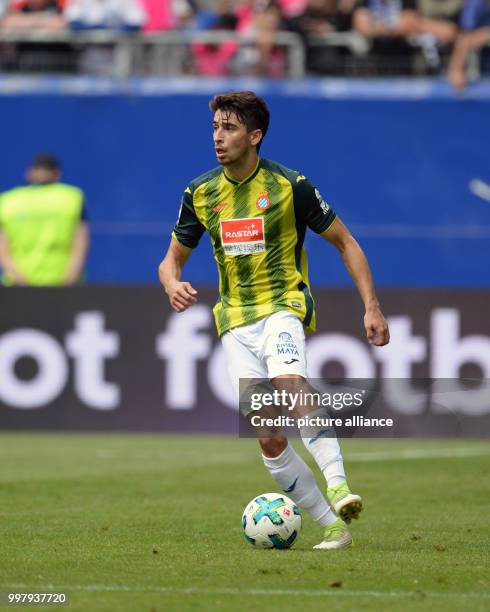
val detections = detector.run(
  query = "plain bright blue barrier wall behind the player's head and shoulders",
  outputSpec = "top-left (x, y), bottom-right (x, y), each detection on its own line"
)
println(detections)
top-left (0, 78), bottom-right (490, 287)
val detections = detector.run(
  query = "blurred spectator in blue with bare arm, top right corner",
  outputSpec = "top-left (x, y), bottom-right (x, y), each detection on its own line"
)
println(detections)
top-left (448, 0), bottom-right (490, 89)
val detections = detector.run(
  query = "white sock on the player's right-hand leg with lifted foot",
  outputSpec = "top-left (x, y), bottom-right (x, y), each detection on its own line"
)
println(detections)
top-left (300, 410), bottom-right (346, 487)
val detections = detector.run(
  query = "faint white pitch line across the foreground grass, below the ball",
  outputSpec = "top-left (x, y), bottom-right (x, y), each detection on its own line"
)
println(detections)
top-left (1, 584), bottom-right (490, 599)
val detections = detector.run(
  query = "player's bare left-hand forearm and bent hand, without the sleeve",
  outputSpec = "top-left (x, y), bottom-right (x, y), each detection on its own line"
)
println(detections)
top-left (158, 237), bottom-right (197, 312)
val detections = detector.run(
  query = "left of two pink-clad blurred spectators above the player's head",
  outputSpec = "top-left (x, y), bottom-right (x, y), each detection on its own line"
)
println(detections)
top-left (193, 0), bottom-right (238, 76)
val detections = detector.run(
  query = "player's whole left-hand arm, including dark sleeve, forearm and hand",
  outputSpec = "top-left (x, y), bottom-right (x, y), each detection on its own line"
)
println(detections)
top-left (158, 187), bottom-right (206, 312)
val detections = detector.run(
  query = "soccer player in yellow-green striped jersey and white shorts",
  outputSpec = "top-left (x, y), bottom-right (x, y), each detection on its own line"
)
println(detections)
top-left (159, 92), bottom-right (389, 549)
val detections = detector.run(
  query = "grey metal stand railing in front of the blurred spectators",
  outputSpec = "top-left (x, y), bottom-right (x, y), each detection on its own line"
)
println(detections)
top-left (0, 30), bottom-right (488, 80)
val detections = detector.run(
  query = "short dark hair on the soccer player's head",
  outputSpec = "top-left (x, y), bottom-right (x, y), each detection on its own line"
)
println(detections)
top-left (209, 91), bottom-right (270, 151)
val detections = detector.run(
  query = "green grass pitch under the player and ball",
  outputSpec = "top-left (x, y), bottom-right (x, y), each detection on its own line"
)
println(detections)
top-left (0, 433), bottom-right (490, 612)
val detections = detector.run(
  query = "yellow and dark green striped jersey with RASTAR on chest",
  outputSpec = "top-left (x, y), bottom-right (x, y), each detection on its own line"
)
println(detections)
top-left (172, 159), bottom-right (336, 336)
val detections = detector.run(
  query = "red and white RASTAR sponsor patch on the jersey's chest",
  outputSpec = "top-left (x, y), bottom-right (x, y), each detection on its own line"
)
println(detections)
top-left (220, 217), bottom-right (265, 256)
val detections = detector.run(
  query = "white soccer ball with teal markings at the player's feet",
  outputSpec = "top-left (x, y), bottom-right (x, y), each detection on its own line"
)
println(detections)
top-left (242, 493), bottom-right (301, 548)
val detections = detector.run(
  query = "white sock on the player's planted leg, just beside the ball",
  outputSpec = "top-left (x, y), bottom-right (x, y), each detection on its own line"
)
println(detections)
top-left (262, 444), bottom-right (337, 527)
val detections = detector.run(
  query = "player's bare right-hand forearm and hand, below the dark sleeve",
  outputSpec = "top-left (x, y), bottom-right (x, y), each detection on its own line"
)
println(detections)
top-left (321, 217), bottom-right (390, 346)
